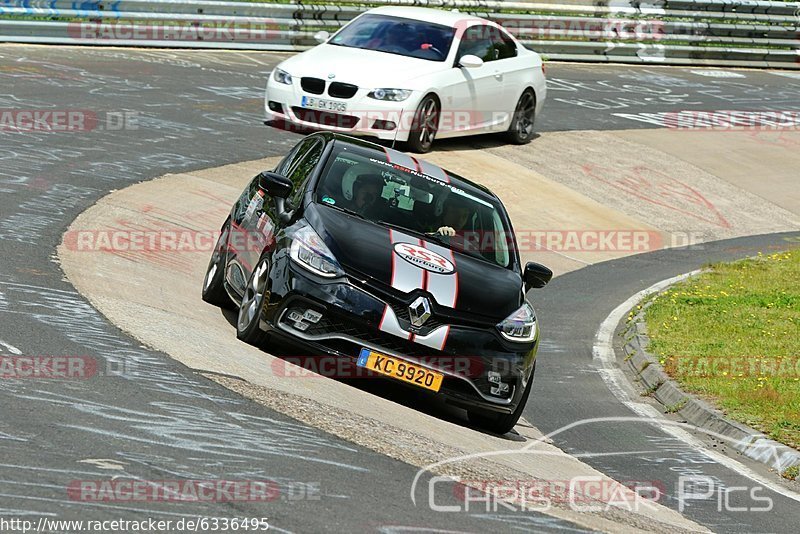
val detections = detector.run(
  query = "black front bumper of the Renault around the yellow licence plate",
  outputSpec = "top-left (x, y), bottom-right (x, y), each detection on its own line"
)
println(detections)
top-left (262, 251), bottom-right (538, 413)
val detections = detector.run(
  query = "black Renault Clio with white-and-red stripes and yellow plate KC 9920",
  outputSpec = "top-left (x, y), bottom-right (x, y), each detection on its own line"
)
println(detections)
top-left (203, 133), bottom-right (552, 433)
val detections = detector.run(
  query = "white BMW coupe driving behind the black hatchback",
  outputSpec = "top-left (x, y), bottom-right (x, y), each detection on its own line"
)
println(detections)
top-left (264, 7), bottom-right (546, 152)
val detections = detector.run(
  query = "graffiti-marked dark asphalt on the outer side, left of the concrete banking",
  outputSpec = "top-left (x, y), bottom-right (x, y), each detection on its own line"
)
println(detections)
top-left (0, 47), bottom-right (581, 532)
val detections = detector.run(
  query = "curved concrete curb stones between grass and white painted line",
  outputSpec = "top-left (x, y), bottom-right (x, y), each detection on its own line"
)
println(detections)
top-left (617, 304), bottom-right (800, 473)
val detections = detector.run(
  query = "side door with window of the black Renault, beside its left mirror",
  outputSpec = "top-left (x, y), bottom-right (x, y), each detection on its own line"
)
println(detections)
top-left (234, 136), bottom-right (325, 280)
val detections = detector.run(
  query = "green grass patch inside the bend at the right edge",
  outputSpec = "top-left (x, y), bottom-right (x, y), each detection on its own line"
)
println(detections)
top-left (646, 250), bottom-right (800, 448)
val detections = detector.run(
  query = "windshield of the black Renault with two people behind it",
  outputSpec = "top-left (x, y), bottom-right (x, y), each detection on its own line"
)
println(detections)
top-left (315, 145), bottom-right (513, 267)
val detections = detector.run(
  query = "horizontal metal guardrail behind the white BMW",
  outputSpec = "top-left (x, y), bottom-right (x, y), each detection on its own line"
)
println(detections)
top-left (0, 0), bottom-right (800, 69)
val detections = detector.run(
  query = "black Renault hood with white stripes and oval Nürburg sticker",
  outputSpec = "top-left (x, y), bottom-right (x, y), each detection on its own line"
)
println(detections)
top-left (306, 203), bottom-right (522, 322)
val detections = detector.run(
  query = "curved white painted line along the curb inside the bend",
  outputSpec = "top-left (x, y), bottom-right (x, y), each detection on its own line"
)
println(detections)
top-left (592, 269), bottom-right (800, 502)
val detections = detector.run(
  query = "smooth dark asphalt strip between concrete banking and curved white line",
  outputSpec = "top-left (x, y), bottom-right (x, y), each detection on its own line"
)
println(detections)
top-left (524, 233), bottom-right (800, 533)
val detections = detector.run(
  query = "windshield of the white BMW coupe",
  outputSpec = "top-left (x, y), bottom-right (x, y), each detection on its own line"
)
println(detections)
top-left (329, 15), bottom-right (455, 61)
